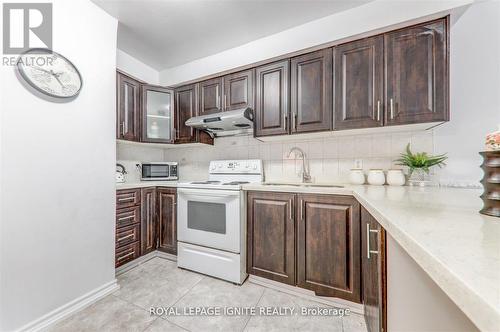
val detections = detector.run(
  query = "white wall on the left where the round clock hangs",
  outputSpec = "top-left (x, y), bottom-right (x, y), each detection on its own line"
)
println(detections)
top-left (0, 0), bottom-right (117, 331)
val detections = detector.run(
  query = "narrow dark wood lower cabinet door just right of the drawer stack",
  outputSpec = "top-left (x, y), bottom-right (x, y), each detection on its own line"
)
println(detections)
top-left (141, 187), bottom-right (157, 255)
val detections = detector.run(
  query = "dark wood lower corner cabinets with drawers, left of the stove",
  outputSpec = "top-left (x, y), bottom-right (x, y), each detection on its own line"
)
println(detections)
top-left (115, 187), bottom-right (177, 267)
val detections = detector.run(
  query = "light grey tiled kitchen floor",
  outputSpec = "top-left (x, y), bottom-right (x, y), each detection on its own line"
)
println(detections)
top-left (49, 258), bottom-right (366, 332)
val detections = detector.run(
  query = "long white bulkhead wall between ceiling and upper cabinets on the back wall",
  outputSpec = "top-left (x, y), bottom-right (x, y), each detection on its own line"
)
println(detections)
top-left (160, 0), bottom-right (473, 85)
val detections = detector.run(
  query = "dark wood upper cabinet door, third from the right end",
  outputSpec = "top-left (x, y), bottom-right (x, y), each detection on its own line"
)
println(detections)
top-left (290, 48), bottom-right (333, 133)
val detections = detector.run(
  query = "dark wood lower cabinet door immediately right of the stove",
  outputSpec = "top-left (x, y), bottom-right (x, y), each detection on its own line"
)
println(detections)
top-left (247, 192), bottom-right (295, 285)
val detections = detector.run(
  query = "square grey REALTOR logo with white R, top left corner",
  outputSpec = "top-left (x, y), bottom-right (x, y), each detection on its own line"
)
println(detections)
top-left (3, 3), bottom-right (52, 54)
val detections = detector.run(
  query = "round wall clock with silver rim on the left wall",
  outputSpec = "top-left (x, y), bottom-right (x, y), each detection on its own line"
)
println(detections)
top-left (17, 49), bottom-right (82, 98)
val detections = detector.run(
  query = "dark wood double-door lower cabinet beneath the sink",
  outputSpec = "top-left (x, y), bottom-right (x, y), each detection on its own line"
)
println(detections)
top-left (247, 192), bottom-right (361, 303)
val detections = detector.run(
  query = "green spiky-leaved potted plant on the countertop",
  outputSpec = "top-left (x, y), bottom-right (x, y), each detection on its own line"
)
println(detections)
top-left (395, 143), bottom-right (448, 186)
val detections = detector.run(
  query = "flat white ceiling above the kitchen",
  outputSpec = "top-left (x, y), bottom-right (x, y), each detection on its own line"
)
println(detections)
top-left (92, 0), bottom-right (370, 70)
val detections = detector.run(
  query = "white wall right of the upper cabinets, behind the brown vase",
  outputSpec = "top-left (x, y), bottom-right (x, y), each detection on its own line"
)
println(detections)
top-left (434, 1), bottom-right (500, 183)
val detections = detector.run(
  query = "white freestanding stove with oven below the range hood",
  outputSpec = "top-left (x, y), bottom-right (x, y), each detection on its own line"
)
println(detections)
top-left (177, 160), bottom-right (264, 284)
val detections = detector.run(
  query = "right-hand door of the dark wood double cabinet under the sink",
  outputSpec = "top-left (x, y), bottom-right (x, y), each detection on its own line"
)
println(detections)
top-left (297, 194), bottom-right (361, 303)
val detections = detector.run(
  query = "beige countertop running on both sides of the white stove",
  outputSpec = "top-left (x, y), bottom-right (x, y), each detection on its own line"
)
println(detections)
top-left (116, 181), bottom-right (500, 331)
